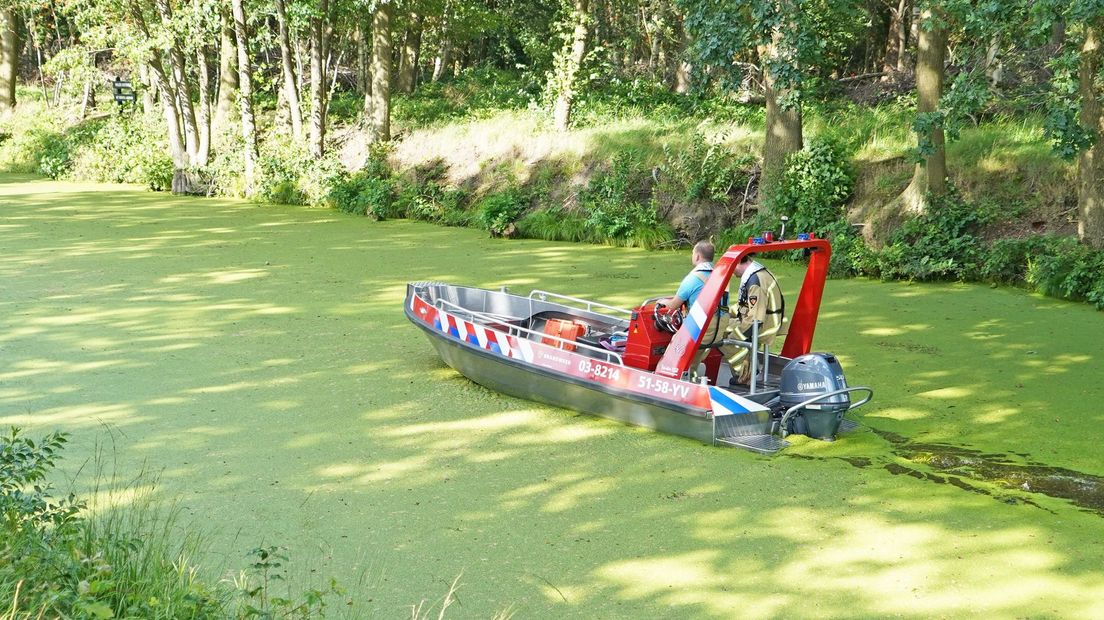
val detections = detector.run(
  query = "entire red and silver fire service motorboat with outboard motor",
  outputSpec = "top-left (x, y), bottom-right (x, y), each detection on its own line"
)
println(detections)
top-left (404, 234), bottom-right (873, 453)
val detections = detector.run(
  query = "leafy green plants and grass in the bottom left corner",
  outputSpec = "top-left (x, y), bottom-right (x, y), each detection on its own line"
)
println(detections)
top-left (0, 428), bottom-right (222, 619)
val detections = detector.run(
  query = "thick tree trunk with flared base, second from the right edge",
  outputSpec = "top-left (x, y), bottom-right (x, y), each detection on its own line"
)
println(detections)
top-left (902, 9), bottom-right (947, 212)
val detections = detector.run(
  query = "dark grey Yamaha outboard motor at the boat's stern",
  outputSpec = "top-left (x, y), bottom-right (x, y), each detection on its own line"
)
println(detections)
top-left (778, 353), bottom-right (851, 441)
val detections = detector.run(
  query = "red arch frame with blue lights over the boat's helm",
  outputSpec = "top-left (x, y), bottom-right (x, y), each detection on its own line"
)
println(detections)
top-left (656, 239), bottom-right (831, 378)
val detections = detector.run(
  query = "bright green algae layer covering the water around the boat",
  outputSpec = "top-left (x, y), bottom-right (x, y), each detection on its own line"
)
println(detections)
top-left (0, 175), bottom-right (1104, 618)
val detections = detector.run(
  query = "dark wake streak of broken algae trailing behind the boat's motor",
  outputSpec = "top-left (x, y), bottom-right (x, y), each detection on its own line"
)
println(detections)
top-left (874, 430), bottom-right (1104, 516)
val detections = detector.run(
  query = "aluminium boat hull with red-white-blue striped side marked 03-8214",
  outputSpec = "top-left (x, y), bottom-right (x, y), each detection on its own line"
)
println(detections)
top-left (404, 282), bottom-right (772, 447)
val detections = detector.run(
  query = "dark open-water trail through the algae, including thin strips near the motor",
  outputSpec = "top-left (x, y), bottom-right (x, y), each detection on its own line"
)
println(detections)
top-left (789, 429), bottom-right (1104, 516)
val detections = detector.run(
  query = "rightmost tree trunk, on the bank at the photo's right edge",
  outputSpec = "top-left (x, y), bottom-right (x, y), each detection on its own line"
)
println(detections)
top-left (1078, 21), bottom-right (1104, 249)
